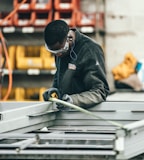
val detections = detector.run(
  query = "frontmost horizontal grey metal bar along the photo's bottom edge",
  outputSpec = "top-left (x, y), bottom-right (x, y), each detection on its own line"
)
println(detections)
top-left (0, 150), bottom-right (115, 160)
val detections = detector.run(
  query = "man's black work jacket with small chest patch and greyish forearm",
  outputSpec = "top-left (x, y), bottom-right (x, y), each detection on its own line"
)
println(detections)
top-left (53, 30), bottom-right (109, 108)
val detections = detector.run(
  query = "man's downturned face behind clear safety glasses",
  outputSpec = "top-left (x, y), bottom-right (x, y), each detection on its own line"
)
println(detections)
top-left (45, 38), bottom-right (69, 56)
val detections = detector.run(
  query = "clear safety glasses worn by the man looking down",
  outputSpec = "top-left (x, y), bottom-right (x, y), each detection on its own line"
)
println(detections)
top-left (45, 40), bottom-right (69, 55)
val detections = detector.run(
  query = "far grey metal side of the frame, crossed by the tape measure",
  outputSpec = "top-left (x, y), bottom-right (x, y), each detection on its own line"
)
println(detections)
top-left (55, 101), bottom-right (144, 128)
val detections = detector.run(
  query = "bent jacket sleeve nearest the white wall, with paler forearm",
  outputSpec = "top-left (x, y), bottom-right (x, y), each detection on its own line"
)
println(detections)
top-left (71, 44), bottom-right (109, 108)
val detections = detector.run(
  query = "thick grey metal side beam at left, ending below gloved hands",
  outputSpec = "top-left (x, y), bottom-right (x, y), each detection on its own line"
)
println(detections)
top-left (0, 102), bottom-right (56, 133)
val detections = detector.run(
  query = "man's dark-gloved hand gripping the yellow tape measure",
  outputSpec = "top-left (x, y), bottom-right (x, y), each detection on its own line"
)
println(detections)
top-left (43, 88), bottom-right (60, 101)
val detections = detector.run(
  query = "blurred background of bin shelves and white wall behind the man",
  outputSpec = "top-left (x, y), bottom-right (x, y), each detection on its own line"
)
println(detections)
top-left (0, 0), bottom-right (144, 101)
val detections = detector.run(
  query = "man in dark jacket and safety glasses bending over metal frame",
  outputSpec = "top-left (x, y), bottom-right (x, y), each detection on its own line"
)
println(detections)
top-left (43, 20), bottom-right (109, 108)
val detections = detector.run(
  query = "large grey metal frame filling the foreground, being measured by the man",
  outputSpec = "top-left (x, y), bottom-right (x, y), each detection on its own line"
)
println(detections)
top-left (0, 92), bottom-right (144, 160)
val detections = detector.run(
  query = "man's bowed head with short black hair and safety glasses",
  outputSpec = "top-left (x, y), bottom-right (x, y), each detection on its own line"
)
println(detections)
top-left (44, 20), bottom-right (69, 54)
